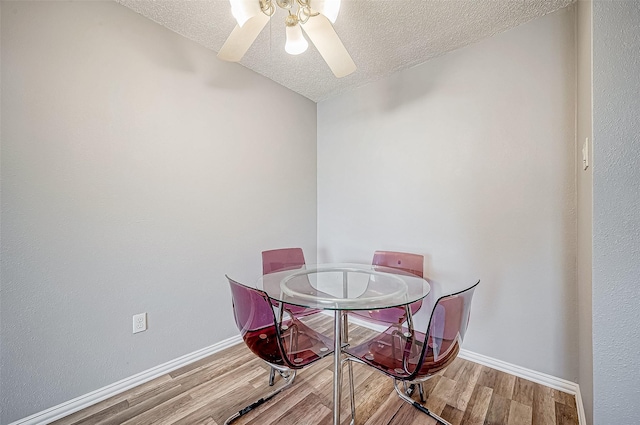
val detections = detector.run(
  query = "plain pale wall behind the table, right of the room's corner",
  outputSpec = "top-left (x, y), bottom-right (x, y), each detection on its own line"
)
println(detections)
top-left (318, 8), bottom-right (578, 381)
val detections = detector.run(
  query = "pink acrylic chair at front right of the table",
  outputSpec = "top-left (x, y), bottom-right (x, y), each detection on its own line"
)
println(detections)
top-left (343, 281), bottom-right (480, 425)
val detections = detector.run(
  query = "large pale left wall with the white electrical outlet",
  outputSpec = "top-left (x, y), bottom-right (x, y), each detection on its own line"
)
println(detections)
top-left (0, 2), bottom-right (316, 423)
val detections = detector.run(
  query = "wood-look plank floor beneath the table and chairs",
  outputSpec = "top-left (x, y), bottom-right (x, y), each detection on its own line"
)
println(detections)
top-left (53, 317), bottom-right (578, 425)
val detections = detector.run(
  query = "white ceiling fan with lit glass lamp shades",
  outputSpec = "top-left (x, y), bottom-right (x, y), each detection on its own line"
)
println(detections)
top-left (218, 0), bottom-right (356, 78)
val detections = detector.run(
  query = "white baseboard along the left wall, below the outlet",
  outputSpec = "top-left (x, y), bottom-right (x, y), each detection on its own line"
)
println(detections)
top-left (9, 335), bottom-right (242, 425)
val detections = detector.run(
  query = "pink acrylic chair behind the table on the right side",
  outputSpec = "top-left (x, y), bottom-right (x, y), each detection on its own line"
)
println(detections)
top-left (350, 251), bottom-right (424, 325)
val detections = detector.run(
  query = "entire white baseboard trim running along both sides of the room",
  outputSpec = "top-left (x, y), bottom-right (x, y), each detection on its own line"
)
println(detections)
top-left (9, 320), bottom-right (587, 425)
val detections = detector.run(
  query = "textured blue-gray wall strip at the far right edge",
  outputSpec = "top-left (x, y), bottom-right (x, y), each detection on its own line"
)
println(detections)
top-left (593, 1), bottom-right (640, 425)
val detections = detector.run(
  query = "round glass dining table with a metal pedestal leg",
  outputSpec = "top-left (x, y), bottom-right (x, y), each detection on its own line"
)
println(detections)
top-left (256, 263), bottom-right (430, 425)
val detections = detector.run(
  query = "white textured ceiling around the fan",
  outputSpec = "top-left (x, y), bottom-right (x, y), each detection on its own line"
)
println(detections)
top-left (116, 0), bottom-right (574, 102)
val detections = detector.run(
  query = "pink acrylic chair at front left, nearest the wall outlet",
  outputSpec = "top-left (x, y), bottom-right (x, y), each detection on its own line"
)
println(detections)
top-left (225, 276), bottom-right (333, 425)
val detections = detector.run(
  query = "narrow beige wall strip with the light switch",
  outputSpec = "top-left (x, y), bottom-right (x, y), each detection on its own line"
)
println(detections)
top-left (576, 0), bottom-right (595, 424)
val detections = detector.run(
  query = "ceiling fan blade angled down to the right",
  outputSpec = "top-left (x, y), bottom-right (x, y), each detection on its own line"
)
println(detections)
top-left (301, 15), bottom-right (357, 78)
